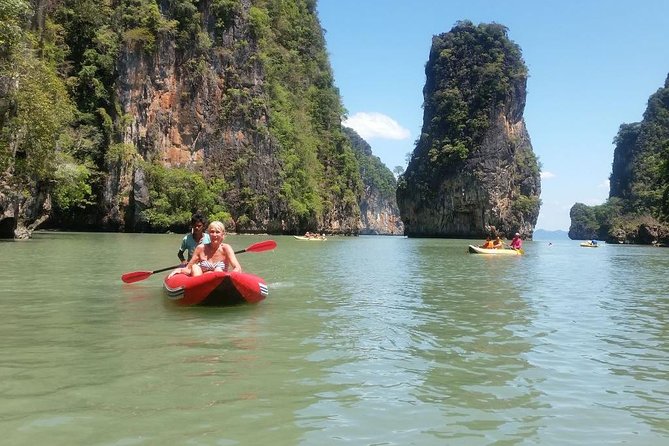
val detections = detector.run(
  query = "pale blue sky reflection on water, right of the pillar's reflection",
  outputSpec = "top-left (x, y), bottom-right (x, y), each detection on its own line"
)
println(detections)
top-left (523, 243), bottom-right (667, 444)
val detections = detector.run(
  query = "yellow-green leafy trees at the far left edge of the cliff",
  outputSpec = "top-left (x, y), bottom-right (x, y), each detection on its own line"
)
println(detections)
top-left (0, 0), bottom-right (79, 213)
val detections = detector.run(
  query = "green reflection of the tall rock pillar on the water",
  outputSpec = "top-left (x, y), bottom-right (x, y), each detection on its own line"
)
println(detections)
top-left (413, 239), bottom-right (541, 441)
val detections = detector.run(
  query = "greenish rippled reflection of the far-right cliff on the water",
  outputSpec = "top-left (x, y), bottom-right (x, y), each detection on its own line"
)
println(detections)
top-left (599, 247), bottom-right (669, 433)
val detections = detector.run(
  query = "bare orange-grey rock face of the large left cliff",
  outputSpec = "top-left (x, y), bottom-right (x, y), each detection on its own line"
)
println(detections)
top-left (103, 0), bottom-right (280, 232)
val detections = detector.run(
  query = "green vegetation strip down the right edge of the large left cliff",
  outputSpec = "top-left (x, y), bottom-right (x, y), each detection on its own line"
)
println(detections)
top-left (254, 0), bottom-right (362, 229)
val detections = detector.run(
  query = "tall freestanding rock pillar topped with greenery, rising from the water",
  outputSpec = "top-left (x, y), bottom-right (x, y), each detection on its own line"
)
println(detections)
top-left (397, 22), bottom-right (541, 238)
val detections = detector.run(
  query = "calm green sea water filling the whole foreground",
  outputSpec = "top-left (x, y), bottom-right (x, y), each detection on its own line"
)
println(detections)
top-left (0, 233), bottom-right (669, 445)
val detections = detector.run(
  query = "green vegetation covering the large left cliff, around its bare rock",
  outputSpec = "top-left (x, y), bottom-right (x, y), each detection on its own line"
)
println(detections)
top-left (0, 0), bottom-right (362, 235)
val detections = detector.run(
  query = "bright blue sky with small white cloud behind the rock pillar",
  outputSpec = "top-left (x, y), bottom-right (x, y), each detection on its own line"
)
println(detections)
top-left (318, 0), bottom-right (669, 230)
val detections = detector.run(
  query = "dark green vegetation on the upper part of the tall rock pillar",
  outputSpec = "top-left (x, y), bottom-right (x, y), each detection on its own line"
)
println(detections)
top-left (414, 21), bottom-right (527, 170)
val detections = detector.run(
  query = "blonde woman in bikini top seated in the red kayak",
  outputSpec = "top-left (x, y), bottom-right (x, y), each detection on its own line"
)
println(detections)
top-left (170, 221), bottom-right (242, 277)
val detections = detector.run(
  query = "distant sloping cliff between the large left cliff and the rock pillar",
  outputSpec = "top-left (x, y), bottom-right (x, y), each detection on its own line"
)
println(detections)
top-left (344, 127), bottom-right (404, 235)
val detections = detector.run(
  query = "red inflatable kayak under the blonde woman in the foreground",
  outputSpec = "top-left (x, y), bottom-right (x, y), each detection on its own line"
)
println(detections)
top-left (163, 271), bottom-right (269, 305)
